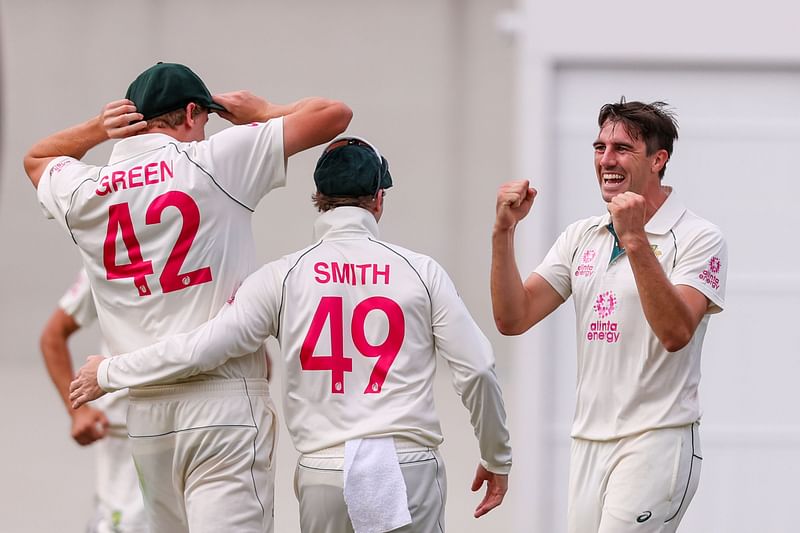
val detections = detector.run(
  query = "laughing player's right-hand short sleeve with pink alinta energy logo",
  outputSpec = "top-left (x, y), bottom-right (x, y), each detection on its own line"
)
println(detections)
top-left (670, 224), bottom-right (728, 313)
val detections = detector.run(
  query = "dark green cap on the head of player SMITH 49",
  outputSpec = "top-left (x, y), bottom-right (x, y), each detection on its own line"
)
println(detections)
top-left (314, 137), bottom-right (392, 197)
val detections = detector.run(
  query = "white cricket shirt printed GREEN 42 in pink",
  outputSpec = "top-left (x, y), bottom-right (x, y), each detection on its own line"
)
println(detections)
top-left (38, 119), bottom-right (286, 386)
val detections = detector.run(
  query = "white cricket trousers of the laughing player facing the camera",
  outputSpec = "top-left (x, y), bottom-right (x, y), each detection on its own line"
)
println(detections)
top-left (567, 423), bottom-right (703, 533)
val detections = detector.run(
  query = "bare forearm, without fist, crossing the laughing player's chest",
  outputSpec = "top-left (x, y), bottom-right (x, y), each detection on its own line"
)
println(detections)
top-left (625, 239), bottom-right (697, 352)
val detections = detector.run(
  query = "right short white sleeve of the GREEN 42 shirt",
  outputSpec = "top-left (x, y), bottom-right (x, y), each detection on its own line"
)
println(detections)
top-left (198, 118), bottom-right (286, 210)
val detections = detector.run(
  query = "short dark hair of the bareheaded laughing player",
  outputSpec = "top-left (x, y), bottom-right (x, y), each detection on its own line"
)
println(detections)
top-left (597, 96), bottom-right (678, 178)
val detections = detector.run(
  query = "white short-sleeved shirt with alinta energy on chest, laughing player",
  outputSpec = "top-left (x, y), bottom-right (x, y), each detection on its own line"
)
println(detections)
top-left (535, 192), bottom-right (728, 440)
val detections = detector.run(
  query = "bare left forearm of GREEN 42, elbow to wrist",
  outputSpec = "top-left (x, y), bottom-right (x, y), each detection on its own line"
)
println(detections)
top-left (24, 117), bottom-right (108, 187)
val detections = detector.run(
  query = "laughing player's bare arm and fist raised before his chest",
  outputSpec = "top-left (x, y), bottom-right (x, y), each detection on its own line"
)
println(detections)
top-left (608, 192), bottom-right (709, 352)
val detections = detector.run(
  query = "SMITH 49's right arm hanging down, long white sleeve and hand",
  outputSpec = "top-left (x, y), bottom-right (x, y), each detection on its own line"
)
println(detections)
top-left (429, 265), bottom-right (511, 517)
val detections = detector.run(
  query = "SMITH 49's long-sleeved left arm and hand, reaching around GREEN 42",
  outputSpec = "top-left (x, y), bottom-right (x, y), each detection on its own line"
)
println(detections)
top-left (69, 265), bottom-right (280, 406)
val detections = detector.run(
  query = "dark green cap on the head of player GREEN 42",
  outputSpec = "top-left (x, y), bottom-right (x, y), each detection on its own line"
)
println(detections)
top-left (125, 62), bottom-right (227, 120)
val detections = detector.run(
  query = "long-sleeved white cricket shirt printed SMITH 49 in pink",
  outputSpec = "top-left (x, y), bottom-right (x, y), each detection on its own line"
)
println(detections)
top-left (98, 207), bottom-right (511, 473)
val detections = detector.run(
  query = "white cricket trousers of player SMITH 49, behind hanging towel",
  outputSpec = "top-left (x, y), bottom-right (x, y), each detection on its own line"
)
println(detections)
top-left (294, 438), bottom-right (447, 533)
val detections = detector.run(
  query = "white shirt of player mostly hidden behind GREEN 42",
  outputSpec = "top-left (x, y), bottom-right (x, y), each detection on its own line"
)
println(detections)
top-left (58, 269), bottom-right (128, 427)
